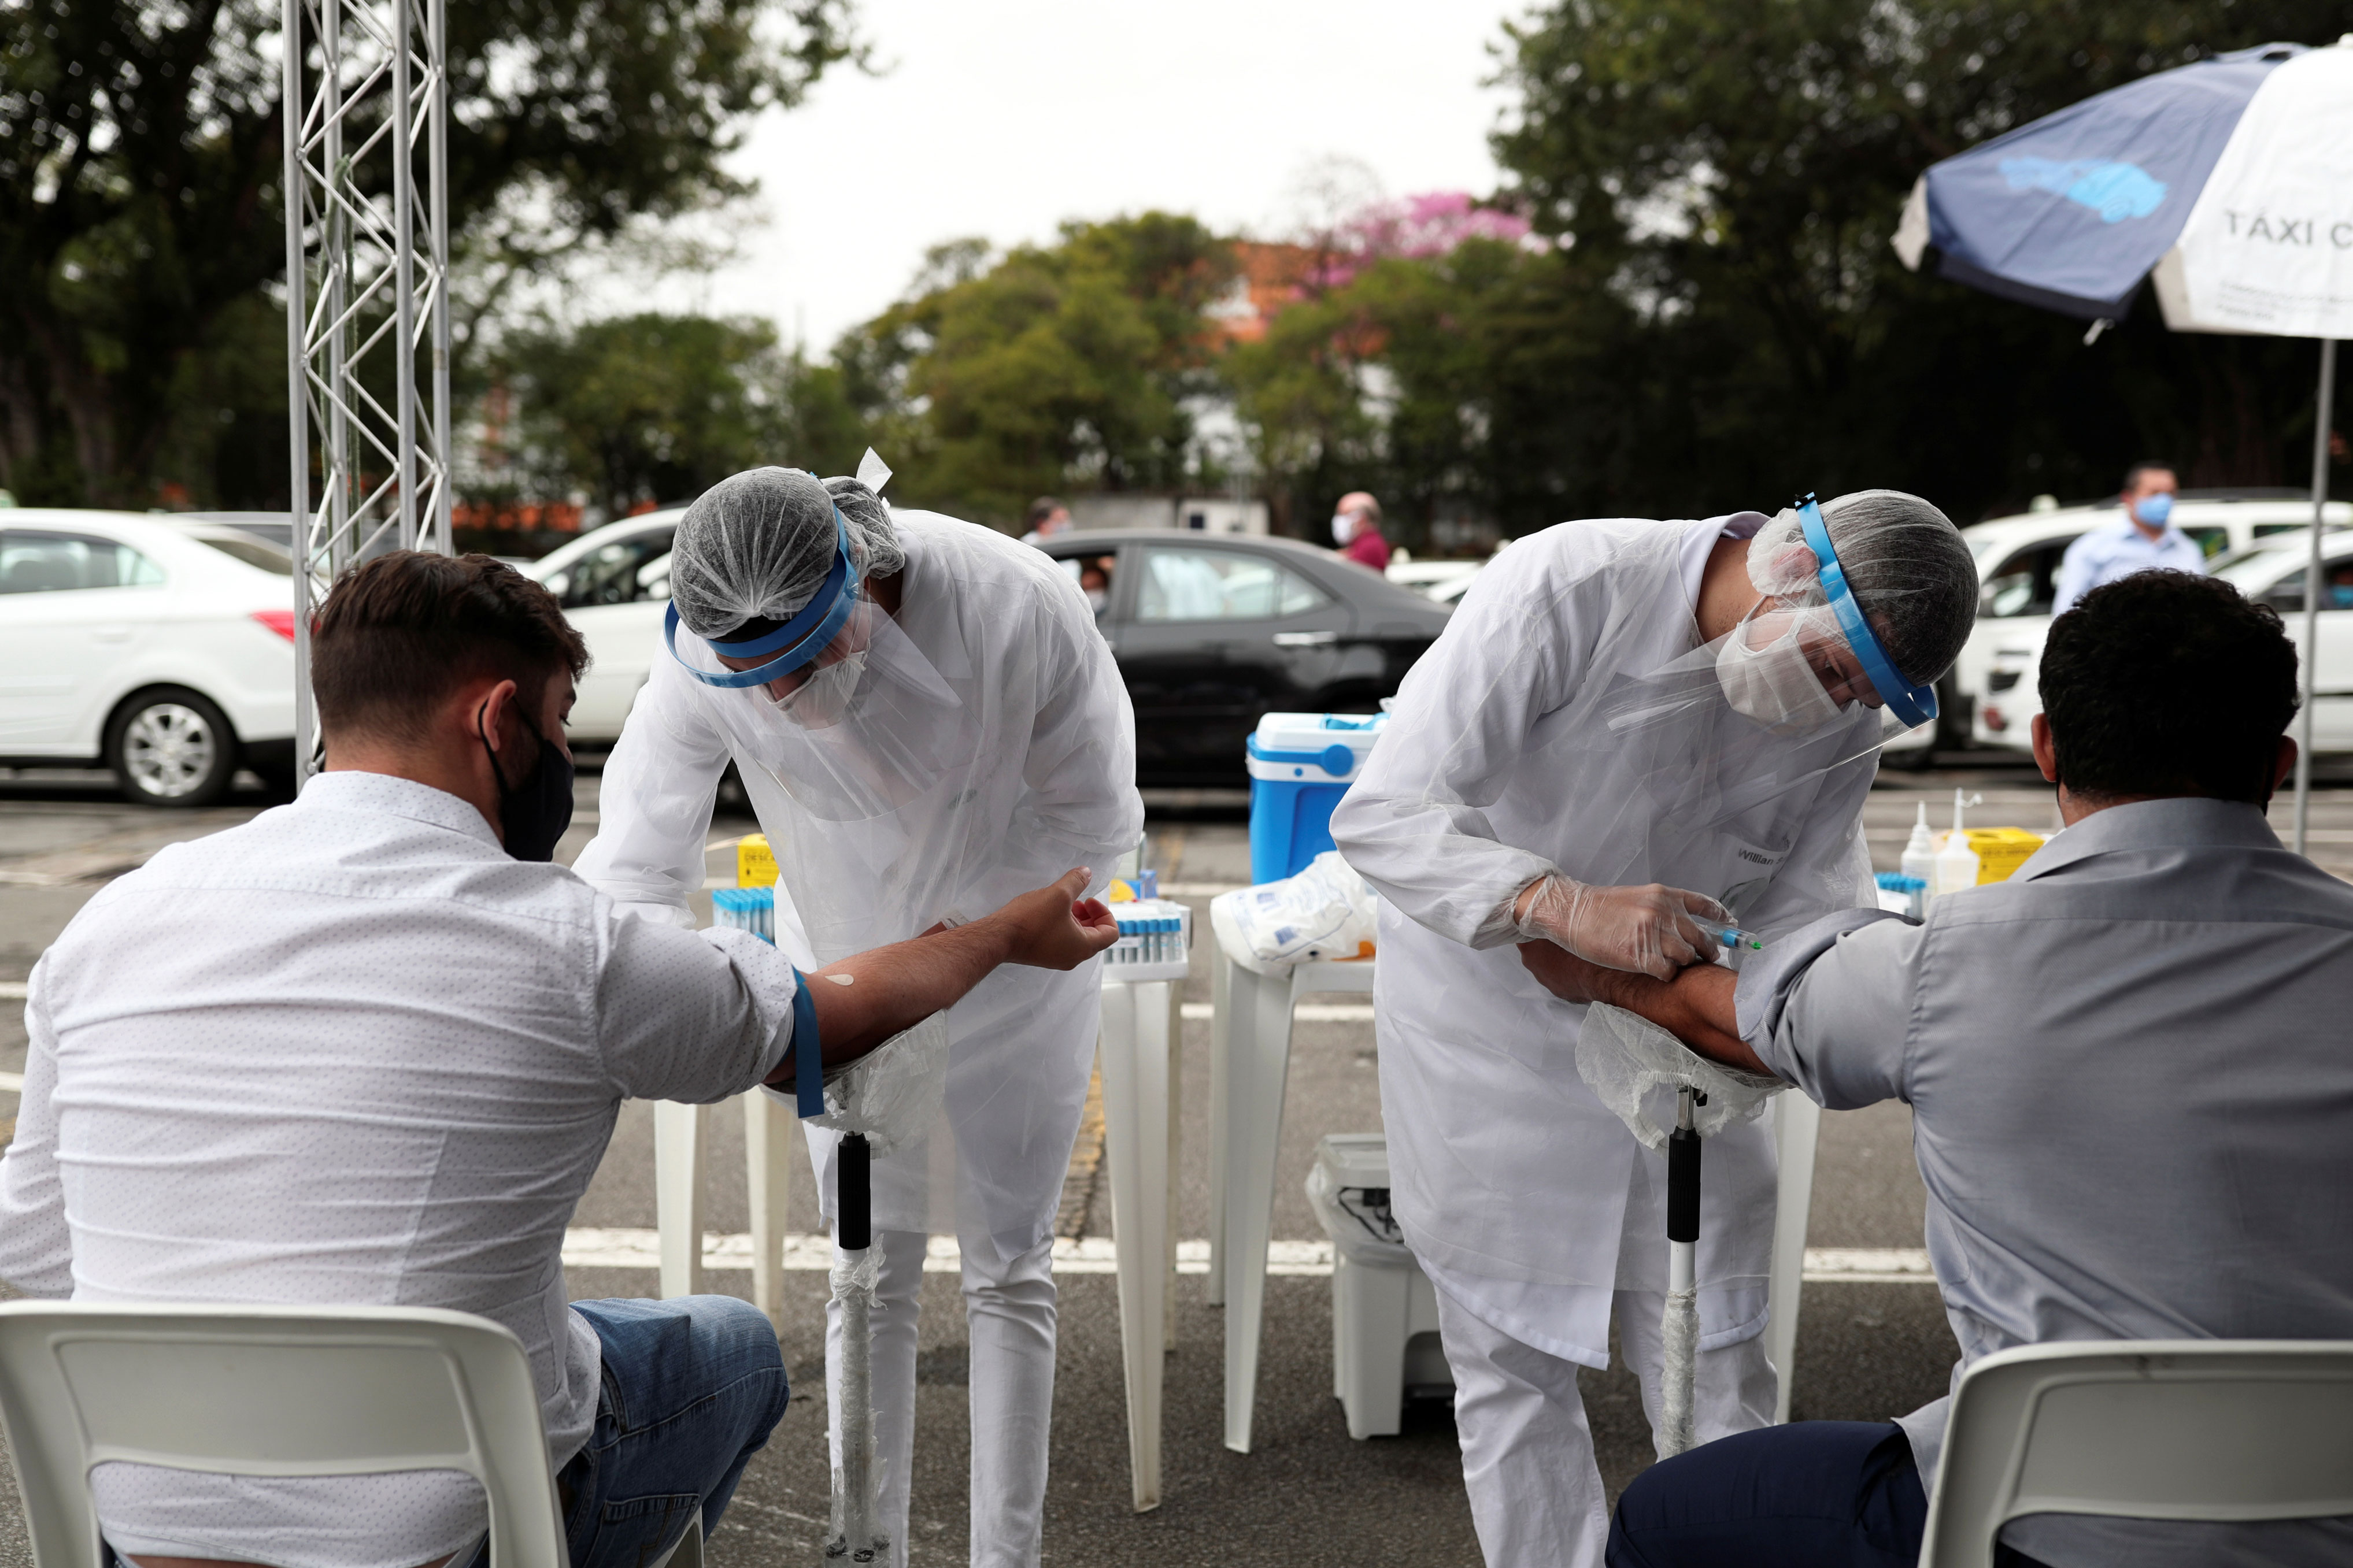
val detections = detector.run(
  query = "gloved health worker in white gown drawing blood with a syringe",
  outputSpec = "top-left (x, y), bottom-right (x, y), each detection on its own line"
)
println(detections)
top-left (1332, 491), bottom-right (1977, 1568)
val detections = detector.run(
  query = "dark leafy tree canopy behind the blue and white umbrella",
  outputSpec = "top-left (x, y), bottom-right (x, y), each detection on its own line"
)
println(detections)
top-left (1497, 0), bottom-right (2344, 522)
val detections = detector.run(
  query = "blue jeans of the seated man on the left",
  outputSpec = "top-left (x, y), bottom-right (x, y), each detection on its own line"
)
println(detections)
top-left (541, 1295), bottom-right (786, 1568)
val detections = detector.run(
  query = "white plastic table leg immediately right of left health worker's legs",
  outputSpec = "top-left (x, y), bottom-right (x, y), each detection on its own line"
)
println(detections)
top-left (1101, 980), bottom-right (1183, 1514)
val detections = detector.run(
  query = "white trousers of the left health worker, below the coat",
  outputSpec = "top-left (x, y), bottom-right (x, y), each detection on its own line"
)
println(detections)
top-left (826, 1229), bottom-right (1054, 1568)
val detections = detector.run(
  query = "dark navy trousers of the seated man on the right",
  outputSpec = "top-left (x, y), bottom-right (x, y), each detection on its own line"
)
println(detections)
top-left (1610, 1420), bottom-right (2040, 1568)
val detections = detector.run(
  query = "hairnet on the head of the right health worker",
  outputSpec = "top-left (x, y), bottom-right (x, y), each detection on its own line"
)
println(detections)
top-left (1748, 489), bottom-right (1977, 687)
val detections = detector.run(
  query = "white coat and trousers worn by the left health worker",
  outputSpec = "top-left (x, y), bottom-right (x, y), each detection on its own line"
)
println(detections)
top-left (579, 510), bottom-right (1144, 1566)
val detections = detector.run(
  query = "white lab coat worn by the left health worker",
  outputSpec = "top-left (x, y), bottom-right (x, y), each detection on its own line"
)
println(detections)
top-left (576, 510), bottom-right (1144, 1258)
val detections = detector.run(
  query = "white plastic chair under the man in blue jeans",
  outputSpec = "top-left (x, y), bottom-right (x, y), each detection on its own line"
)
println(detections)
top-left (0, 1300), bottom-right (701, 1568)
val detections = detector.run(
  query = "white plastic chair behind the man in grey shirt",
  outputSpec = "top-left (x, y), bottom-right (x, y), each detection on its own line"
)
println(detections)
top-left (1920, 1340), bottom-right (2353, 1568)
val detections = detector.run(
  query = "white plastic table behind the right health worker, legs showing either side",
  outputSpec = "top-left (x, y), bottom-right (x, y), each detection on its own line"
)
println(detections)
top-left (1204, 943), bottom-right (1821, 1453)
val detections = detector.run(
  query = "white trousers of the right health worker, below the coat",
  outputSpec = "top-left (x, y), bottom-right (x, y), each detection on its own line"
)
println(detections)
top-left (1438, 1288), bottom-right (1774, 1568)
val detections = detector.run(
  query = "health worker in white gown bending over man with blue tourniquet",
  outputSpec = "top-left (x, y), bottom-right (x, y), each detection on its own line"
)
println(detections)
top-left (576, 454), bottom-right (1144, 1568)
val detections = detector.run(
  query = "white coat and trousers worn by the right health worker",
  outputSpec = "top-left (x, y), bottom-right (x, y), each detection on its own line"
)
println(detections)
top-left (1332, 513), bottom-right (1875, 1568)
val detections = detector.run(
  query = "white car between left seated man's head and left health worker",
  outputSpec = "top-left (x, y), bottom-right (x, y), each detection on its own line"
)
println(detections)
top-left (523, 506), bottom-right (687, 745)
